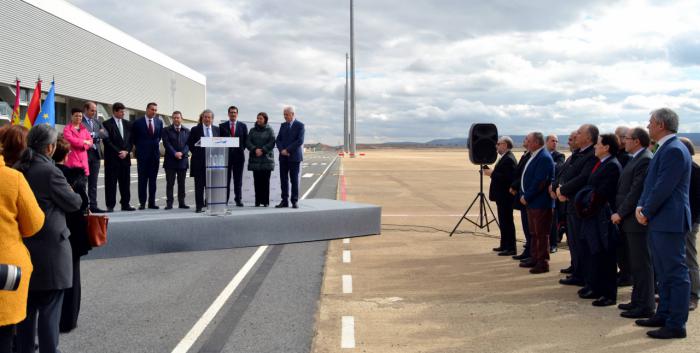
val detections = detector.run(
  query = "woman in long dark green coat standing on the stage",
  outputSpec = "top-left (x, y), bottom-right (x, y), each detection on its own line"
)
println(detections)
top-left (246, 112), bottom-right (275, 207)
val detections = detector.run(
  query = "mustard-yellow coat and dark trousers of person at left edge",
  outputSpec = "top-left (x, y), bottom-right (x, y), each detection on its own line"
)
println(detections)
top-left (0, 152), bottom-right (44, 352)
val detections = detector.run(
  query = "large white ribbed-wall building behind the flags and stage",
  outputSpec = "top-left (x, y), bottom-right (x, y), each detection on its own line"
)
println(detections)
top-left (0, 0), bottom-right (206, 125)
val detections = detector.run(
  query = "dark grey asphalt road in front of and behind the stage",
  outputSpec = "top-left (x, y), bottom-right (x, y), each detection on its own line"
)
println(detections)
top-left (59, 153), bottom-right (339, 353)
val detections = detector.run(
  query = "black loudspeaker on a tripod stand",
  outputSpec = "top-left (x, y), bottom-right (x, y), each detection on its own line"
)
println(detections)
top-left (450, 123), bottom-right (498, 236)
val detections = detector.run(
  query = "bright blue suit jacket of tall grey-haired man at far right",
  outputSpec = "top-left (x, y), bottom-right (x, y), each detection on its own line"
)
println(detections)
top-left (637, 136), bottom-right (691, 233)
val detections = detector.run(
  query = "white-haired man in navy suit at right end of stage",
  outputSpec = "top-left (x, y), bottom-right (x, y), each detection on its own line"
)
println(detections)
top-left (275, 106), bottom-right (304, 208)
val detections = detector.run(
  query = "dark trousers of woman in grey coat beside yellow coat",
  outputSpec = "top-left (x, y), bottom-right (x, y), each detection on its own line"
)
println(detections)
top-left (17, 290), bottom-right (63, 353)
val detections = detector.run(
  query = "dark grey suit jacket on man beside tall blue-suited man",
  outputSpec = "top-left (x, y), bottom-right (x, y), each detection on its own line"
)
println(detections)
top-left (615, 148), bottom-right (651, 233)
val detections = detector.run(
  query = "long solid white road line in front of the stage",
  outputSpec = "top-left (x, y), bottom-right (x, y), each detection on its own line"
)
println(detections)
top-left (172, 245), bottom-right (267, 353)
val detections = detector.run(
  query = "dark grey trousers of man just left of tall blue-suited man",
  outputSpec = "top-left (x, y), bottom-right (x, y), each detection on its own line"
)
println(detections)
top-left (625, 232), bottom-right (656, 311)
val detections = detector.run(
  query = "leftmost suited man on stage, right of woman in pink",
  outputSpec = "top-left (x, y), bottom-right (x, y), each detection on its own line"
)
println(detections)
top-left (83, 102), bottom-right (107, 213)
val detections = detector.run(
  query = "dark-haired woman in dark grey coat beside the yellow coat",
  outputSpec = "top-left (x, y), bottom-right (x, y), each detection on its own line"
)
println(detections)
top-left (15, 124), bottom-right (82, 353)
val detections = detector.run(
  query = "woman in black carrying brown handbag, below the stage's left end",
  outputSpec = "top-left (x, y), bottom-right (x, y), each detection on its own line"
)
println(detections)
top-left (53, 137), bottom-right (92, 332)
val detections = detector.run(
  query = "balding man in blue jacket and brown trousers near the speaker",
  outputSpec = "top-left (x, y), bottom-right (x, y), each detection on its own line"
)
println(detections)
top-left (520, 132), bottom-right (554, 274)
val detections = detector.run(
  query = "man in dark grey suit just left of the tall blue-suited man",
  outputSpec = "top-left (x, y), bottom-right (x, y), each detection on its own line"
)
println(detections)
top-left (610, 127), bottom-right (656, 318)
